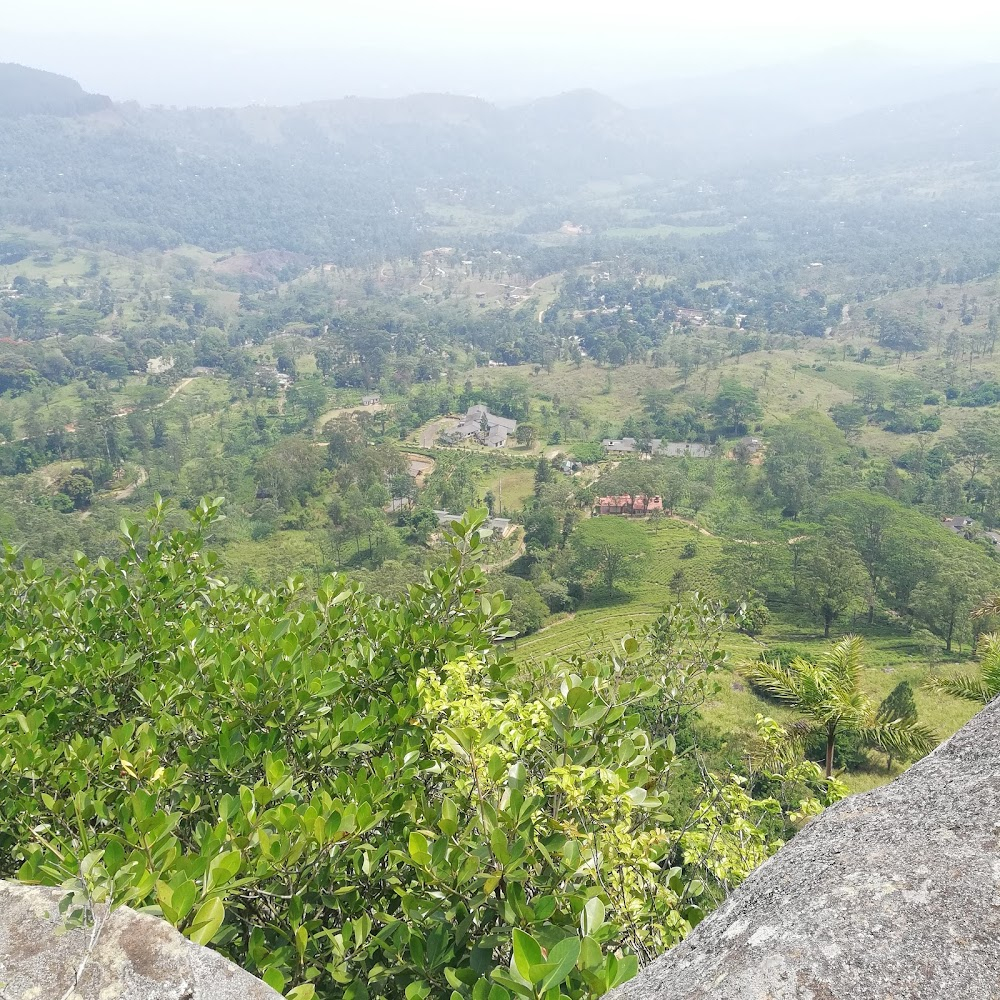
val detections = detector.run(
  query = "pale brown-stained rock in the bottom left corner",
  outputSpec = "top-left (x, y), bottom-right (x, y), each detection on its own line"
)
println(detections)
top-left (0, 882), bottom-right (281, 1000)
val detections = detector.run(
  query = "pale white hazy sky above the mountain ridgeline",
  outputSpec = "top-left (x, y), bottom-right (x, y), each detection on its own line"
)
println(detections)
top-left (0, 0), bottom-right (1000, 104)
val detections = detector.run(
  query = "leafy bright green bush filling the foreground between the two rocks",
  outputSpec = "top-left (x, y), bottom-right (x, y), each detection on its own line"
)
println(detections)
top-left (0, 501), bottom-right (824, 1000)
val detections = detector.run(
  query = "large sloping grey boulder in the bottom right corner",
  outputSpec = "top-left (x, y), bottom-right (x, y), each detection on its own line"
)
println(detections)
top-left (609, 702), bottom-right (1000, 1000)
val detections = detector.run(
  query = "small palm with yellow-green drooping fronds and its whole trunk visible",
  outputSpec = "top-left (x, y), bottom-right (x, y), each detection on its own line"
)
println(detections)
top-left (743, 635), bottom-right (938, 778)
